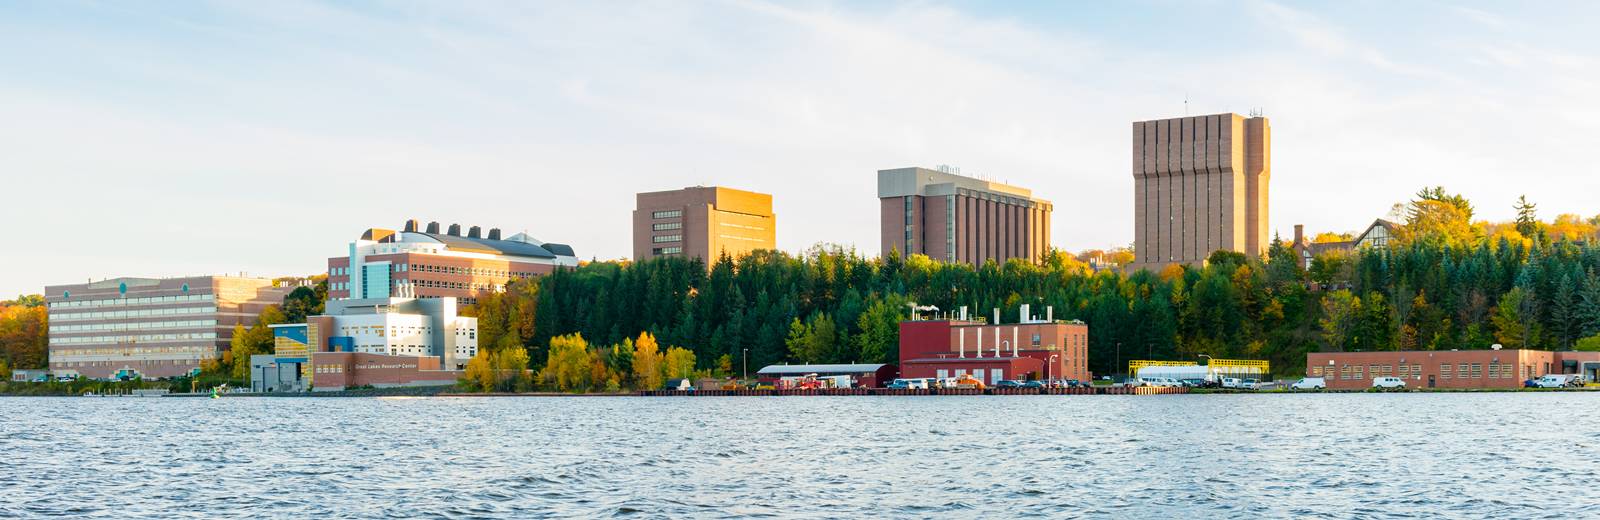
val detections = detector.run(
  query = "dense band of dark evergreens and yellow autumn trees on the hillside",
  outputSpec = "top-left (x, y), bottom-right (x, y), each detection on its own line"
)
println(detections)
top-left (469, 187), bottom-right (1600, 387)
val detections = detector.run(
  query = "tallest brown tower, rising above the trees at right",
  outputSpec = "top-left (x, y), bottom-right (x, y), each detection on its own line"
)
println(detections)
top-left (1130, 114), bottom-right (1272, 270)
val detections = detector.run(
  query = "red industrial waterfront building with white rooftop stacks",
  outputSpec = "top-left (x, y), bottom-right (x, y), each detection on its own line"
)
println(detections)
top-left (899, 306), bottom-right (1090, 384)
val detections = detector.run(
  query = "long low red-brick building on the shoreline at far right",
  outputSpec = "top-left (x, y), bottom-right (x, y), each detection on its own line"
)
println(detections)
top-left (1306, 350), bottom-right (1600, 389)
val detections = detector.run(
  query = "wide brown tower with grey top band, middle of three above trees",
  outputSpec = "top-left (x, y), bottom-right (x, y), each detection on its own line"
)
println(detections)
top-left (878, 168), bottom-right (1053, 264)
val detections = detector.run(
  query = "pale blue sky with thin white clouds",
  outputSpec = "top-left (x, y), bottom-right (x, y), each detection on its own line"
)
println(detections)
top-left (0, 0), bottom-right (1600, 298)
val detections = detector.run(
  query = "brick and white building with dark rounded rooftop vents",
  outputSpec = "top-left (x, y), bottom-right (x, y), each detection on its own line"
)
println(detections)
top-left (328, 221), bottom-right (578, 306)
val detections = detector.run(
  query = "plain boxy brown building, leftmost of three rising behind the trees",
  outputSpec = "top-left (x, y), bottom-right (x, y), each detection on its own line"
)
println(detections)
top-left (634, 186), bottom-right (778, 262)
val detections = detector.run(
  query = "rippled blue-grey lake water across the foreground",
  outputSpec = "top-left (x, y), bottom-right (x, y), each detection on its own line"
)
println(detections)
top-left (0, 394), bottom-right (1600, 518)
